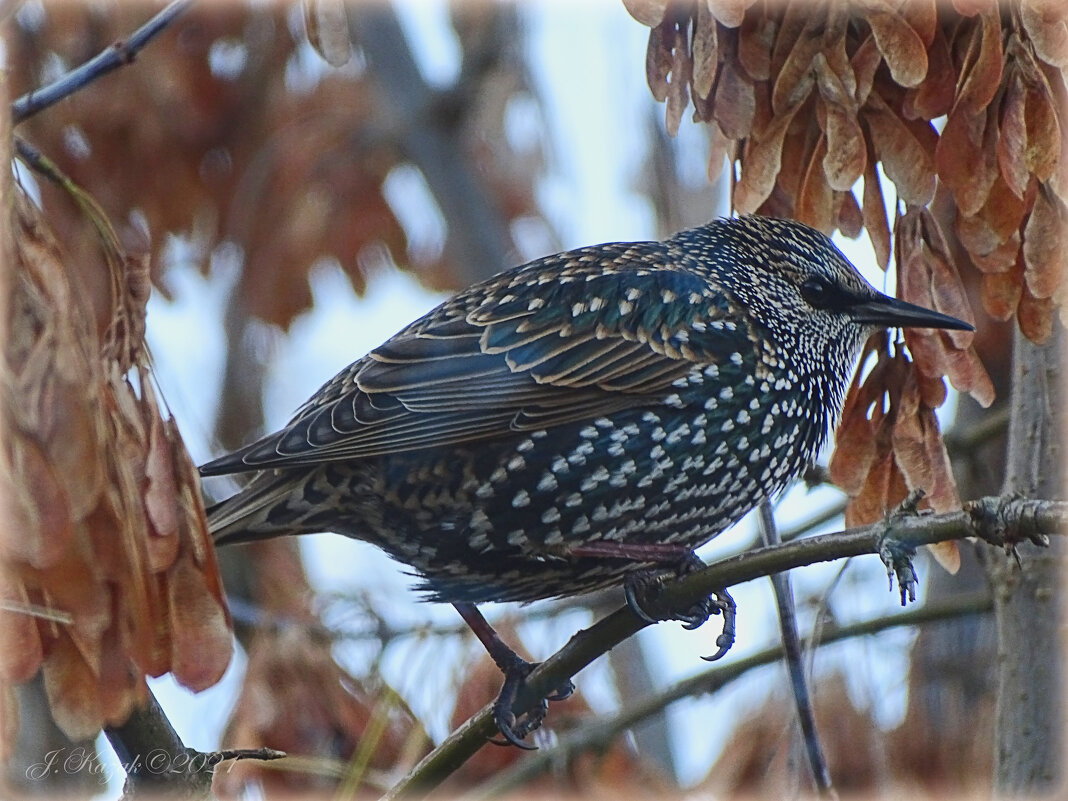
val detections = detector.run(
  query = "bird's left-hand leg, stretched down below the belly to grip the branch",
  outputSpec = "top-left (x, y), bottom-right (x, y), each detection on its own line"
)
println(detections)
top-left (453, 602), bottom-right (575, 751)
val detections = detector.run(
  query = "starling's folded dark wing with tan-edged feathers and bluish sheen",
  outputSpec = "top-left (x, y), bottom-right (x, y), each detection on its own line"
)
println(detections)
top-left (201, 254), bottom-right (753, 475)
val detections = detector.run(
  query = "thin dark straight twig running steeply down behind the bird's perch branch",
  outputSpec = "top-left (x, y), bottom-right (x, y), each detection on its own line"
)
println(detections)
top-left (760, 501), bottom-right (838, 799)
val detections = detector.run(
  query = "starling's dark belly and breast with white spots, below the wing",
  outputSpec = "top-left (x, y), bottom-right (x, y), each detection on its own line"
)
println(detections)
top-left (371, 363), bottom-right (818, 570)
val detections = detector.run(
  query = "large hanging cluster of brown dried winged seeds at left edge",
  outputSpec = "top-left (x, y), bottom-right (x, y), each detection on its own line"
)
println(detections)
top-left (0, 186), bottom-right (233, 757)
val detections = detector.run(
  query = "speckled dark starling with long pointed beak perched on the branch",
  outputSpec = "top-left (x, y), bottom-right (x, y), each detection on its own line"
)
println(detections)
top-left (201, 217), bottom-right (971, 745)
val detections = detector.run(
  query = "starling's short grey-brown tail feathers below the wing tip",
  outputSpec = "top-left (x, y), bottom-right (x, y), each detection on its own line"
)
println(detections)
top-left (207, 471), bottom-right (304, 546)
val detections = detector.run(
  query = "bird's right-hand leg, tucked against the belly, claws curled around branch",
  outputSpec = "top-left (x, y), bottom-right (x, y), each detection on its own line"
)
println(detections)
top-left (570, 541), bottom-right (738, 661)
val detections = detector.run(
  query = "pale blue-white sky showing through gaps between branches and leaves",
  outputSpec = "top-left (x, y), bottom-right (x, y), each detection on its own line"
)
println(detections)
top-left (111, 0), bottom-right (925, 795)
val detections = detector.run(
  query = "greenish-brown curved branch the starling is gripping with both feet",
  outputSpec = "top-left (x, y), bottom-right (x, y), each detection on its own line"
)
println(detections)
top-left (386, 498), bottom-right (1068, 799)
